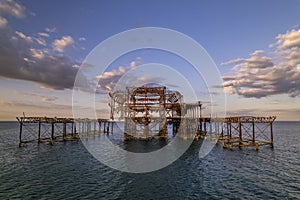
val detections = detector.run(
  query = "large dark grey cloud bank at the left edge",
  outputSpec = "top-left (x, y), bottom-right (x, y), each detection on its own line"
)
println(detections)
top-left (0, 25), bottom-right (78, 90)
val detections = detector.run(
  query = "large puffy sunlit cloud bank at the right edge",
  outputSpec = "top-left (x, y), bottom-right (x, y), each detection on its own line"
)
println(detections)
top-left (222, 30), bottom-right (300, 98)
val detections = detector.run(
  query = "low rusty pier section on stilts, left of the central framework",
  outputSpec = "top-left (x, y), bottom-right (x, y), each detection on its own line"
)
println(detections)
top-left (16, 116), bottom-right (113, 146)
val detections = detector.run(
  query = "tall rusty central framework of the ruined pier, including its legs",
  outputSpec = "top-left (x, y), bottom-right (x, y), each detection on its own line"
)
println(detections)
top-left (109, 86), bottom-right (201, 139)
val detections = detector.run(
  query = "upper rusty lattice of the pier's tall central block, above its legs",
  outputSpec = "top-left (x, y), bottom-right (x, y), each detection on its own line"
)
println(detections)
top-left (109, 87), bottom-right (182, 120)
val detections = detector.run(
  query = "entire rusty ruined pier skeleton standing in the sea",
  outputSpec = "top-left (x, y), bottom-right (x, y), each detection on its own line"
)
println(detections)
top-left (17, 86), bottom-right (276, 149)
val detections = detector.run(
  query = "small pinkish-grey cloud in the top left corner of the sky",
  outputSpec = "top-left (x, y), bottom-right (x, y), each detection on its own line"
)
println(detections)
top-left (0, 0), bottom-right (25, 18)
